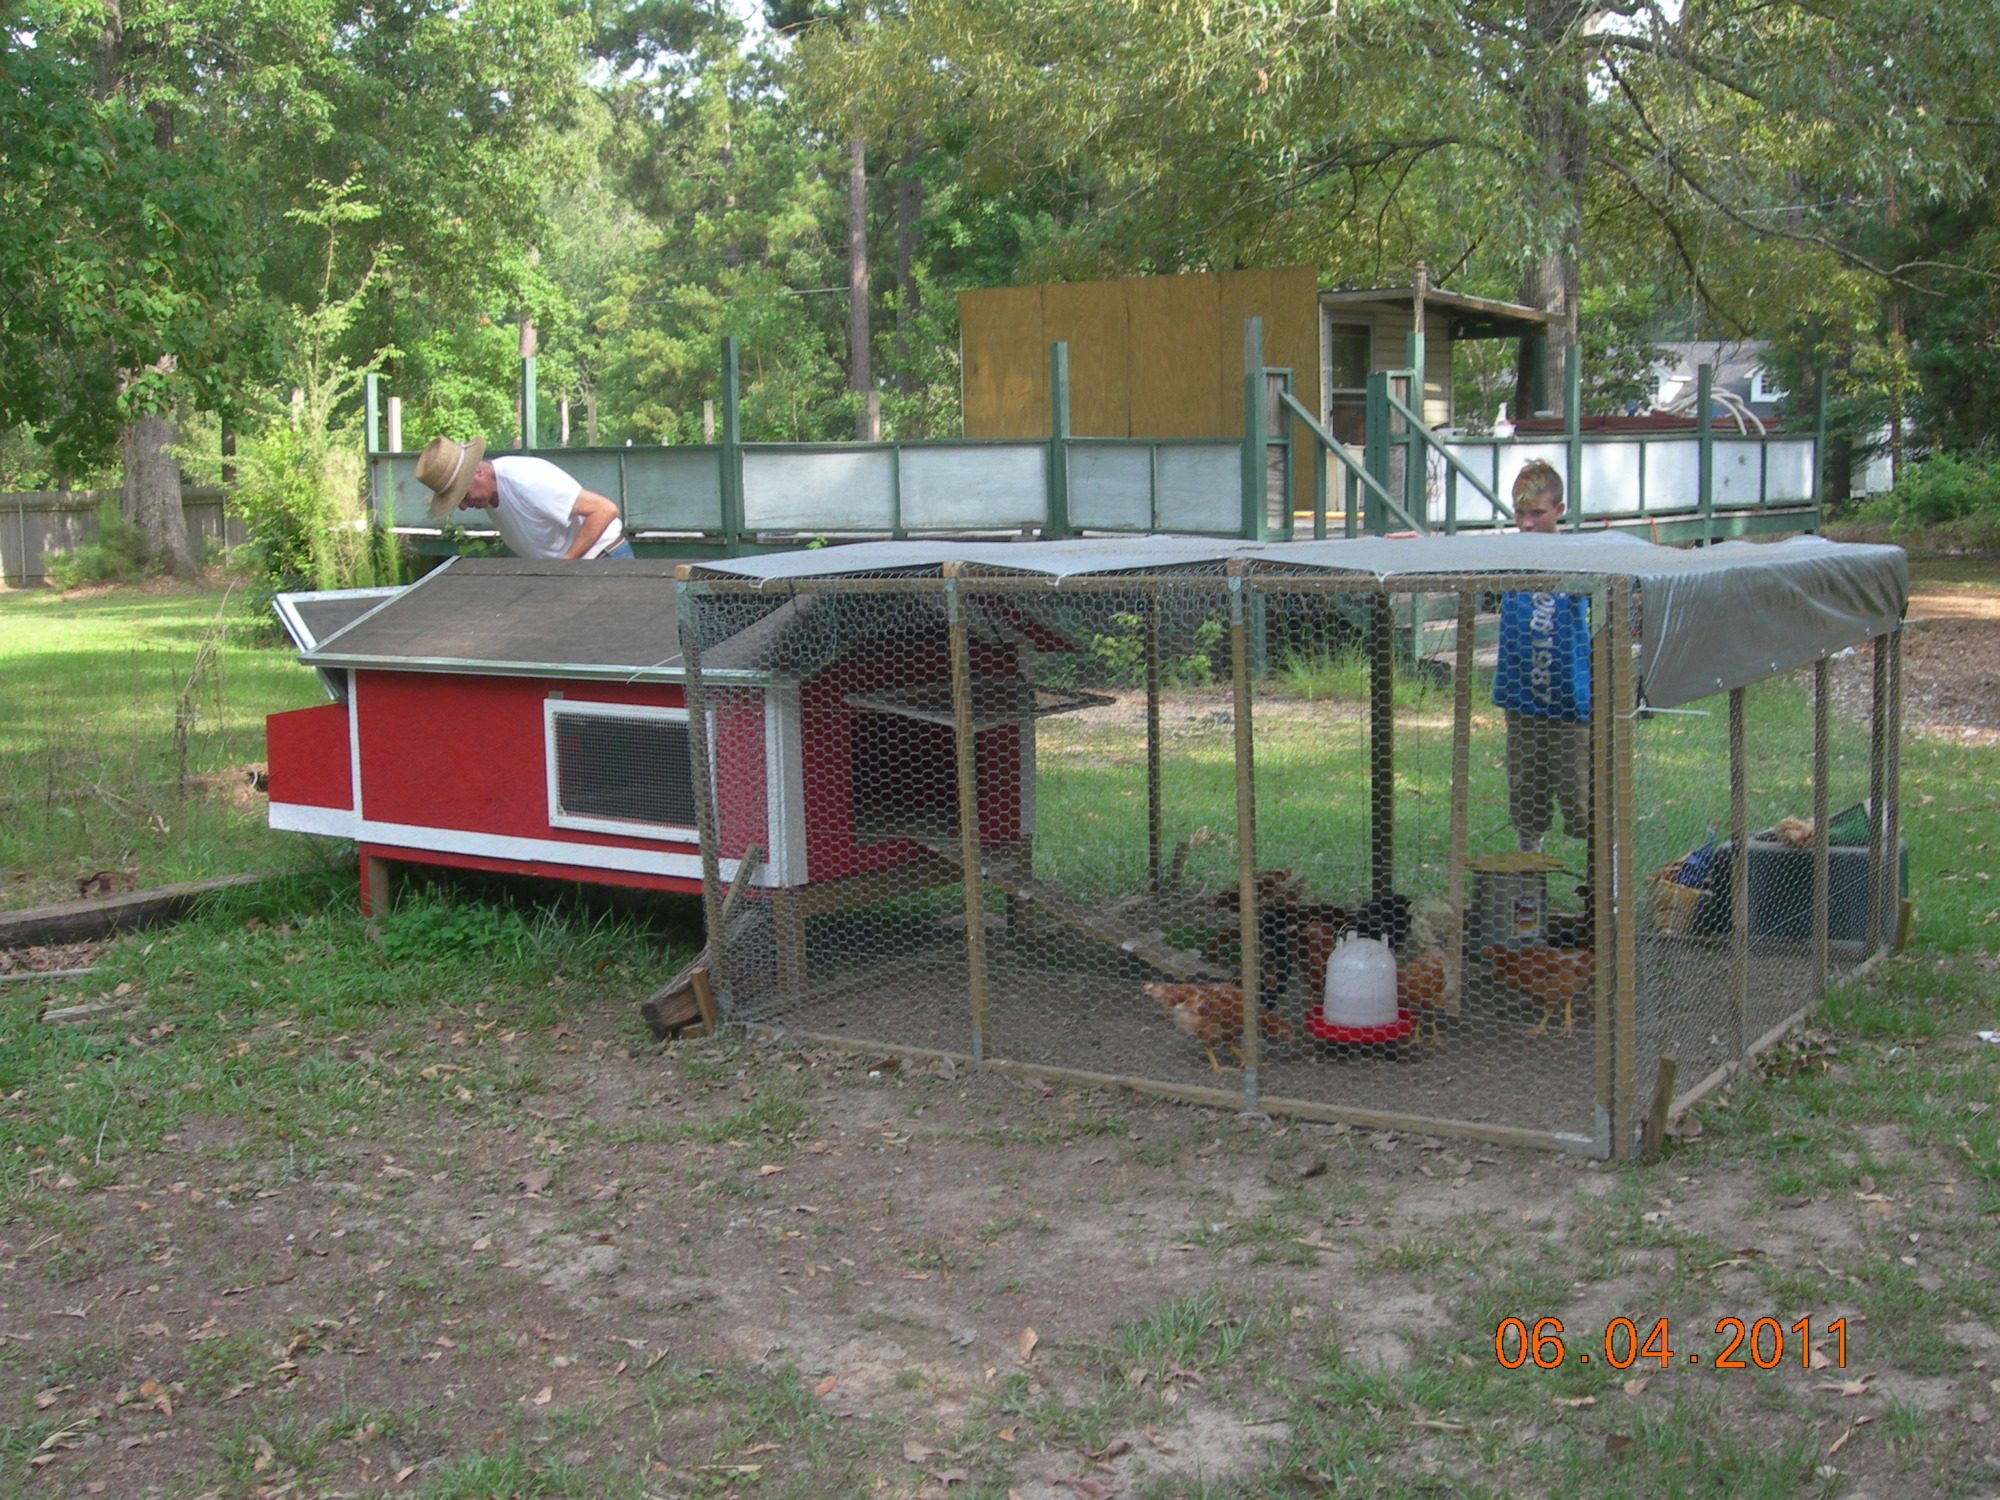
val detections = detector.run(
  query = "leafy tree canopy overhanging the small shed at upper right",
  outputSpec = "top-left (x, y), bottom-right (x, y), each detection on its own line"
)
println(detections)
top-left (800, 0), bottom-right (1996, 424)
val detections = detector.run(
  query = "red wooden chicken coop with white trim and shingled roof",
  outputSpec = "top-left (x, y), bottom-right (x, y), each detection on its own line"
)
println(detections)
top-left (266, 558), bottom-right (1090, 914)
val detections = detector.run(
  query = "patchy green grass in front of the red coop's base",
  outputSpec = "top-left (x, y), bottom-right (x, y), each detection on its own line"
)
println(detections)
top-left (0, 870), bottom-right (692, 1228)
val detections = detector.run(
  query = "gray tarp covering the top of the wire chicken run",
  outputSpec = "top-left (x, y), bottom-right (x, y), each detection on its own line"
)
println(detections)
top-left (696, 532), bottom-right (1910, 708)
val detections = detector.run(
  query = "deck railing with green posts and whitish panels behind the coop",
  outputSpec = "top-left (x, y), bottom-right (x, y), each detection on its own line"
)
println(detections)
top-left (366, 318), bottom-right (1824, 556)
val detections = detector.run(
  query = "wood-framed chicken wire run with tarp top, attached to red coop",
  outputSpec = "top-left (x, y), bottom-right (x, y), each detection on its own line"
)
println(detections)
top-left (678, 534), bottom-right (1908, 1156)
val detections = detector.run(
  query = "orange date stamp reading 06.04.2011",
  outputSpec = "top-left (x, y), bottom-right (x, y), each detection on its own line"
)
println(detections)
top-left (1494, 1314), bottom-right (1848, 1370)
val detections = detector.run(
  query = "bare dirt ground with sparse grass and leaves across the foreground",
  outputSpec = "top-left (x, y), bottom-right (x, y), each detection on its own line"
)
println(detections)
top-left (0, 560), bottom-right (2000, 1500)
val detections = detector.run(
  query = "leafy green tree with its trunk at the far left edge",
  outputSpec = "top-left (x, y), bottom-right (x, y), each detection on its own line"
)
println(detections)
top-left (0, 22), bottom-right (260, 572)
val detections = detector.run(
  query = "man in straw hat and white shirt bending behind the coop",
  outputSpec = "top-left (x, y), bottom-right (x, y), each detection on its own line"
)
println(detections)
top-left (416, 438), bottom-right (632, 560)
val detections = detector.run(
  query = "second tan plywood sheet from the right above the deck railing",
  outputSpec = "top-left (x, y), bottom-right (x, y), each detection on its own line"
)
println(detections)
top-left (1124, 276), bottom-right (1216, 438)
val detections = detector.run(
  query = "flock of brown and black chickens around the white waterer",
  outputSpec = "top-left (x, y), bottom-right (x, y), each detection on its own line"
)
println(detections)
top-left (1144, 870), bottom-right (1596, 1072)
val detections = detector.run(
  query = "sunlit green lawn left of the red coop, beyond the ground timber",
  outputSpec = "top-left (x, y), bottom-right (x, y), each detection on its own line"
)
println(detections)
top-left (0, 588), bottom-right (326, 908)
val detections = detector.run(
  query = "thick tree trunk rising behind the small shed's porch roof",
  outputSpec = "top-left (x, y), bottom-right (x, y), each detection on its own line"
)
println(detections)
top-left (1514, 0), bottom-right (1592, 416)
